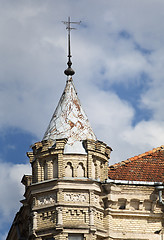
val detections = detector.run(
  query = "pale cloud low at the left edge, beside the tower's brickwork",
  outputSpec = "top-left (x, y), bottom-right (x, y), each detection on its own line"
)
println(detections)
top-left (0, 162), bottom-right (31, 231)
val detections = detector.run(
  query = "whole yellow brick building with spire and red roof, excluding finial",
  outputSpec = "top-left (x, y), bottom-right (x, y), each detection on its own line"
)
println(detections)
top-left (7, 73), bottom-right (164, 240)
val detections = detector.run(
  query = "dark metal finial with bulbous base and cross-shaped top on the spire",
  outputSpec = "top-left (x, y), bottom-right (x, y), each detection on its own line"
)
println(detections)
top-left (63, 17), bottom-right (81, 76)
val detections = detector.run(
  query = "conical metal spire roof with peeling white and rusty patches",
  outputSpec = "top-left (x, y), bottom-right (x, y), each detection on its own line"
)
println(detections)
top-left (43, 76), bottom-right (96, 145)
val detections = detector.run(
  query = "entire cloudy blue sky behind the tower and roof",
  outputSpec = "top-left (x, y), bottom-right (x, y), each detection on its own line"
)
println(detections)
top-left (0, 0), bottom-right (164, 240)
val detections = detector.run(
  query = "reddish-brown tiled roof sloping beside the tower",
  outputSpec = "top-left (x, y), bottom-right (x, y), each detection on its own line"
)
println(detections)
top-left (108, 145), bottom-right (164, 182)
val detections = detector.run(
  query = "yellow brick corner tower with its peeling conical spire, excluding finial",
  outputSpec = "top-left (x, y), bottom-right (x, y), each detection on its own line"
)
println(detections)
top-left (23, 76), bottom-right (111, 240)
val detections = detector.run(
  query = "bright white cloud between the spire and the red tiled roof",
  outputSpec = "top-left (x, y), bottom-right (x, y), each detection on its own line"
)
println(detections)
top-left (83, 90), bottom-right (164, 164)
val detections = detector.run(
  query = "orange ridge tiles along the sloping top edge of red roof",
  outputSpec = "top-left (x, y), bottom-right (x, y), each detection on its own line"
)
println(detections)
top-left (109, 145), bottom-right (164, 169)
